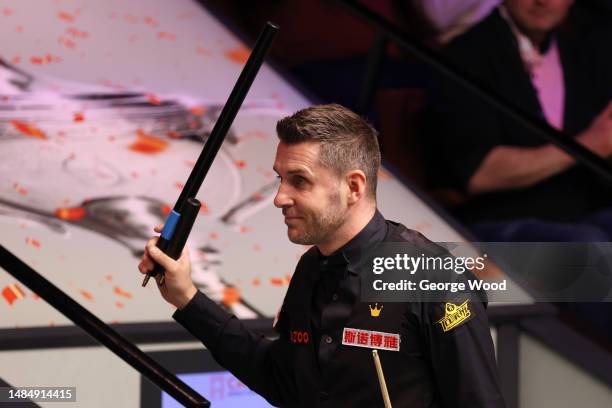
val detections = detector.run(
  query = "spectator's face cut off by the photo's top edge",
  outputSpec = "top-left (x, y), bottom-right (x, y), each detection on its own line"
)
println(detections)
top-left (505, 0), bottom-right (574, 34)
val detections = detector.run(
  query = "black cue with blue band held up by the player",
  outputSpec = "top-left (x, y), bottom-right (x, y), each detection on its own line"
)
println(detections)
top-left (142, 22), bottom-right (278, 286)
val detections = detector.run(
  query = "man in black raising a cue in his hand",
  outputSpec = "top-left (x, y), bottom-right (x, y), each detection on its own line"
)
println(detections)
top-left (139, 105), bottom-right (503, 408)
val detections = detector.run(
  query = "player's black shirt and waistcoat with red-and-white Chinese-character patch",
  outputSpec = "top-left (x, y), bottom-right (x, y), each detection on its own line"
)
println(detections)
top-left (173, 213), bottom-right (504, 408)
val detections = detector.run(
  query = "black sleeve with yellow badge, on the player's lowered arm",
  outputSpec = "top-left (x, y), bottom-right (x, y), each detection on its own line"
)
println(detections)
top-left (422, 299), bottom-right (505, 408)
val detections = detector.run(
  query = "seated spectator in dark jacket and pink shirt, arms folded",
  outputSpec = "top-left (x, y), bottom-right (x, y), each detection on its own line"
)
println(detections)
top-left (438, 0), bottom-right (612, 241)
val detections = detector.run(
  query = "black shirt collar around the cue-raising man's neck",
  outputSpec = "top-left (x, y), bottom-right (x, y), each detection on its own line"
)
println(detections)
top-left (317, 210), bottom-right (387, 273)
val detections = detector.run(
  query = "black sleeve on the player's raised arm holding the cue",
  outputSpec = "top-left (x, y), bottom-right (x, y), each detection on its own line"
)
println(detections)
top-left (172, 291), bottom-right (297, 406)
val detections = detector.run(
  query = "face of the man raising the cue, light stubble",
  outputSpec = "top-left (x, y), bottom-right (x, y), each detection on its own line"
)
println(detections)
top-left (274, 142), bottom-right (347, 245)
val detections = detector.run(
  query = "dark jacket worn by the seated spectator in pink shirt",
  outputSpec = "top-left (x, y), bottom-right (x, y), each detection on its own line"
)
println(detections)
top-left (436, 10), bottom-right (612, 222)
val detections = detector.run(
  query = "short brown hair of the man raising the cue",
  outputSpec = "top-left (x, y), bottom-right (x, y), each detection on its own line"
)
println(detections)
top-left (276, 104), bottom-right (380, 198)
